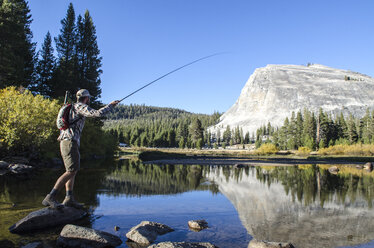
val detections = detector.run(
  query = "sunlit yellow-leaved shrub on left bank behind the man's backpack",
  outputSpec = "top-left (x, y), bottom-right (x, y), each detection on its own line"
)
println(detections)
top-left (0, 87), bottom-right (60, 155)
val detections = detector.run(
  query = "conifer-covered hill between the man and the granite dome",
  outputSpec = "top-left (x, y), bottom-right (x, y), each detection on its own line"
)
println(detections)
top-left (104, 105), bottom-right (220, 149)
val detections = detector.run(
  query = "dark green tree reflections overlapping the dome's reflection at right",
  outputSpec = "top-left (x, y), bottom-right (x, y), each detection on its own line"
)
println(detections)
top-left (255, 165), bottom-right (374, 208)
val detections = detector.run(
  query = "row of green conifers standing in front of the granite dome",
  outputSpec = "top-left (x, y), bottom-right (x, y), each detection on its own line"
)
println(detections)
top-left (256, 109), bottom-right (374, 150)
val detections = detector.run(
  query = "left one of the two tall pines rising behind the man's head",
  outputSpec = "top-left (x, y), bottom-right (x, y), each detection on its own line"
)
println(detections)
top-left (51, 3), bottom-right (77, 98)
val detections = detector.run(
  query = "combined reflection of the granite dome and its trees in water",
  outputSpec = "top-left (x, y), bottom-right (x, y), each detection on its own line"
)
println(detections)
top-left (204, 165), bottom-right (374, 247)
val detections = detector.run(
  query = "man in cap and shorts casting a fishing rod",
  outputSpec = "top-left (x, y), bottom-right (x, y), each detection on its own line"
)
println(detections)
top-left (42, 89), bottom-right (119, 208)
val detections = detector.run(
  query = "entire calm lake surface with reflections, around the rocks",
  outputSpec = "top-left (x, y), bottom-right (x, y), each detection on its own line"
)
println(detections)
top-left (0, 160), bottom-right (374, 248)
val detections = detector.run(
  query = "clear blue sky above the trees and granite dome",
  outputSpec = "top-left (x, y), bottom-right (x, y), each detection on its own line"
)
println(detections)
top-left (29, 0), bottom-right (374, 114)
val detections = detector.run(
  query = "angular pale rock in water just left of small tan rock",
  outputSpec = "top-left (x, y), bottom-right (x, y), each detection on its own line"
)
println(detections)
top-left (126, 221), bottom-right (174, 244)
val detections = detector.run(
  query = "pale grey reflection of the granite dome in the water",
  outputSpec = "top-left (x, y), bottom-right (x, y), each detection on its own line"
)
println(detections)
top-left (206, 167), bottom-right (374, 247)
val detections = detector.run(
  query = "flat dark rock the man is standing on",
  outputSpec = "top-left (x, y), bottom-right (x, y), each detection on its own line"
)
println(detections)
top-left (9, 207), bottom-right (87, 233)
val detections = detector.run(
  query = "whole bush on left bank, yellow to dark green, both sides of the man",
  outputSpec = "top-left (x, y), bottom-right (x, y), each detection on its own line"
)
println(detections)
top-left (0, 87), bottom-right (117, 158)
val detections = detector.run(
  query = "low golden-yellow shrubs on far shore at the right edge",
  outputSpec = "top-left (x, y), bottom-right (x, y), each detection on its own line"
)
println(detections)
top-left (318, 144), bottom-right (374, 156)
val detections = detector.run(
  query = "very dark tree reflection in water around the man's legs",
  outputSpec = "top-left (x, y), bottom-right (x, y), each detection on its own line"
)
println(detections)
top-left (0, 160), bottom-right (114, 209)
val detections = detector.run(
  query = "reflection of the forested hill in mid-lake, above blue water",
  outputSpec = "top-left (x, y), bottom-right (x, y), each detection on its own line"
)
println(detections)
top-left (104, 160), bottom-right (218, 196)
